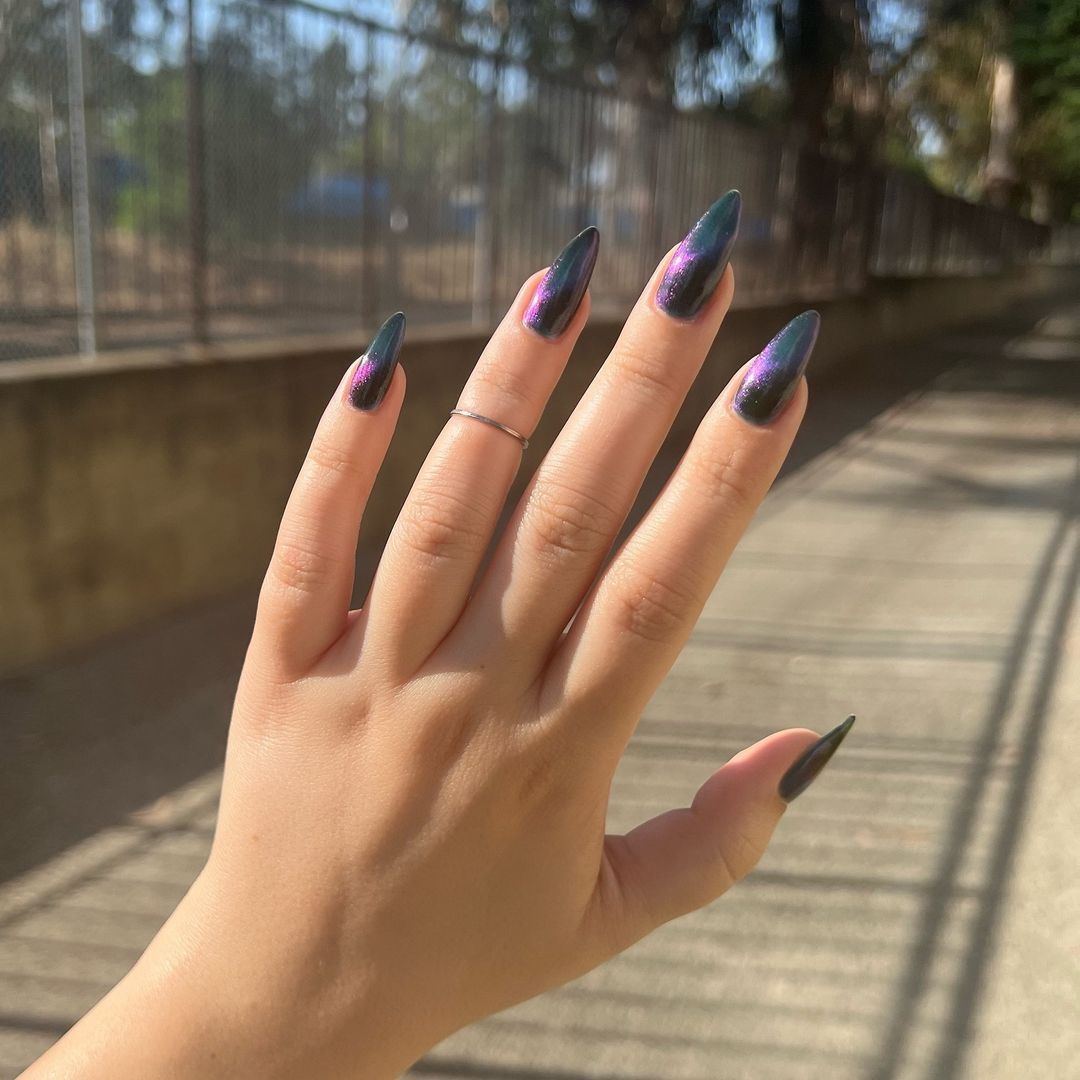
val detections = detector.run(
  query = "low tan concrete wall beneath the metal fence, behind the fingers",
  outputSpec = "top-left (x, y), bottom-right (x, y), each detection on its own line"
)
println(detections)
top-left (0, 271), bottom-right (1062, 672)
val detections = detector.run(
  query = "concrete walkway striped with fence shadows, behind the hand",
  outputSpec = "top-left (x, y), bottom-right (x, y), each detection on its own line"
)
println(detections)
top-left (0, 295), bottom-right (1080, 1080)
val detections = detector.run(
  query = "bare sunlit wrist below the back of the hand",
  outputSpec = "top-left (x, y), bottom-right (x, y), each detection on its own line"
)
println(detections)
top-left (27, 879), bottom-right (428, 1080)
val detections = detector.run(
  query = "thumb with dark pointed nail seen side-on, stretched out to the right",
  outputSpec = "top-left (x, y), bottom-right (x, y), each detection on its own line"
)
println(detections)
top-left (594, 716), bottom-right (855, 950)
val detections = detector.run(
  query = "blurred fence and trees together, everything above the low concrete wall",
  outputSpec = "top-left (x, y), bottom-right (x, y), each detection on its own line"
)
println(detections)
top-left (0, 0), bottom-right (1080, 359)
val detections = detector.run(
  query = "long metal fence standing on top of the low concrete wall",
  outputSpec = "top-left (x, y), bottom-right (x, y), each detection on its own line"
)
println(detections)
top-left (0, 0), bottom-right (1062, 359)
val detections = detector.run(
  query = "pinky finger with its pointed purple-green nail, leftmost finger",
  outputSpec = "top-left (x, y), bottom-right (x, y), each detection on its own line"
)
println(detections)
top-left (252, 312), bottom-right (405, 678)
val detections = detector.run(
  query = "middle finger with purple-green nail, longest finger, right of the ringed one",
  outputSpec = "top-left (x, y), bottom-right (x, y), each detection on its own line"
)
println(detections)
top-left (451, 191), bottom-right (741, 669)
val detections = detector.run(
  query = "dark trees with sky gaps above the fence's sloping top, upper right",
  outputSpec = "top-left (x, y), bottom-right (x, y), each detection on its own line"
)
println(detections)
top-left (408, 0), bottom-right (1080, 215)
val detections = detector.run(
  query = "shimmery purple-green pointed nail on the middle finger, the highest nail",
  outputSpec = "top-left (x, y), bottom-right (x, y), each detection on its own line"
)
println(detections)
top-left (657, 191), bottom-right (742, 319)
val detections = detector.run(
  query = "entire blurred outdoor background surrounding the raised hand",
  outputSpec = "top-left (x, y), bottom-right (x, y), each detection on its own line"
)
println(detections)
top-left (0, 0), bottom-right (1080, 1080)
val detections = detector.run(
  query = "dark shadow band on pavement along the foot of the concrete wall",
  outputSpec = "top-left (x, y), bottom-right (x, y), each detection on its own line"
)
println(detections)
top-left (0, 306), bottom-right (997, 894)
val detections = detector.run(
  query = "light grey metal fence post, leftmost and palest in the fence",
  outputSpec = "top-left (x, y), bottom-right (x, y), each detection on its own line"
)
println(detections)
top-left (67, 0), bottom-right (97, 356)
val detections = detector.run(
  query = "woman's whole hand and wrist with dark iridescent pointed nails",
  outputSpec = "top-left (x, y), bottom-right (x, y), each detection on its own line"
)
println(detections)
top-left (27, 192), bottom-right (847, 1078)
